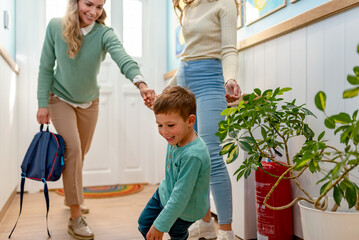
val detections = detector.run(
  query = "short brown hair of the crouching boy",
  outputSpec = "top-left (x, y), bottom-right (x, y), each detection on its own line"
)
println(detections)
top-left (153, 86), bottom-right (196, 120)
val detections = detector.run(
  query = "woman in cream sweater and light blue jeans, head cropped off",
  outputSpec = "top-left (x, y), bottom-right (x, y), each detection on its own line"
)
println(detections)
top-left (169, 0), bottom-right (241, 239)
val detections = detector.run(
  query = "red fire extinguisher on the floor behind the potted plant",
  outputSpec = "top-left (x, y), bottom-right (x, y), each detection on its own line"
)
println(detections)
top-left (255, 160), bottom-right (293, 240)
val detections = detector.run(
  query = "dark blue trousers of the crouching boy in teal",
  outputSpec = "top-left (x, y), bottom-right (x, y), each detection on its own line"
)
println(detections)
top-left (138, 189), bottom-right (193, 240)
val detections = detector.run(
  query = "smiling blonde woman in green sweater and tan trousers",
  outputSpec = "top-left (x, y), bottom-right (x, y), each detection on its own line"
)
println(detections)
top-left (37, 0), bottom-right (155, 239)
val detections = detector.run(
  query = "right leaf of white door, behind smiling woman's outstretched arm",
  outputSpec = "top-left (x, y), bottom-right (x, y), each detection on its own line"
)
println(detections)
top-left (84, 0), bottom-right (166, 186)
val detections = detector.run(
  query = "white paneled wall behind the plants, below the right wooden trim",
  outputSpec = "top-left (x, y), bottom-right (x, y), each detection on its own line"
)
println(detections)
top-left (234, 7), bottom-right (359, 237)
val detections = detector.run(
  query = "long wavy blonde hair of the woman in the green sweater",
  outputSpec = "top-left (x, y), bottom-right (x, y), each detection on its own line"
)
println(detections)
top-left (62, 0), bottom-right (107, 59)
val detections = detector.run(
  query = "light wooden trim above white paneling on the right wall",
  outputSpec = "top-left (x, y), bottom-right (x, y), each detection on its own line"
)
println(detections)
top-left (237, 0), bottom-right (359, 51)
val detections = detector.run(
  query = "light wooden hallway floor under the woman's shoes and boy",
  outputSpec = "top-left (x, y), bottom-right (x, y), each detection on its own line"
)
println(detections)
top-left (0, 185), bottom-right (242, 240)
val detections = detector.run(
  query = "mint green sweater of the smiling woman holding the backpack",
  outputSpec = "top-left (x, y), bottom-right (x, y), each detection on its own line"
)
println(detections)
top-left (37, 18), bottom-right (141, 108)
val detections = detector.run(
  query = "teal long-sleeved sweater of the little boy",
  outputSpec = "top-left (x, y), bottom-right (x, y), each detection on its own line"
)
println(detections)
top-left (153, 136), bottom-right (211, 232)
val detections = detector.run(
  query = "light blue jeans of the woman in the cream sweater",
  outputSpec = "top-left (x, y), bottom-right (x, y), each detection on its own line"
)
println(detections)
top-left (177, 59), bottom-right (232, 224)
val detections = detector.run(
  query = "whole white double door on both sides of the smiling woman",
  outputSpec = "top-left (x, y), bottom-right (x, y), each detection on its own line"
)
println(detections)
top-left (16, 0), bottom-right (167, 191)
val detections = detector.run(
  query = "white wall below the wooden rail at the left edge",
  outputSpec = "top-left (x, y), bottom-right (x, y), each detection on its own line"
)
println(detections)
top-left (0, 56), bottom-right (20, 214)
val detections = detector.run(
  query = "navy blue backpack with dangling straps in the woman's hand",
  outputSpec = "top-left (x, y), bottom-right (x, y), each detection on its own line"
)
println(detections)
top-left (9, 125), bottom-right (65, 238)
